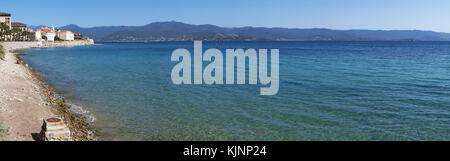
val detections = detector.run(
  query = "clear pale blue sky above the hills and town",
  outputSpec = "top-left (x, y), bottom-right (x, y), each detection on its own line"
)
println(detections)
top-left (0, 0), bottom-right (450, 33)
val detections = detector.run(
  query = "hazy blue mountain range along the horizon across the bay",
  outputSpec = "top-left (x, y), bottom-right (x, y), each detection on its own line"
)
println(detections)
top-left (60, 21), bottom-right (450, 42)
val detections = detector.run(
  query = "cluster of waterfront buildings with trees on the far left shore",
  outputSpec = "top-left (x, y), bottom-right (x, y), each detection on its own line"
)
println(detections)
top-left (0, 12), bottom-right (88, 42)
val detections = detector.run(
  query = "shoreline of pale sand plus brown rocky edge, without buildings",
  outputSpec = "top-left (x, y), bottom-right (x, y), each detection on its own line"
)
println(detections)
top-left (0, 40), bottom-right (96, 141)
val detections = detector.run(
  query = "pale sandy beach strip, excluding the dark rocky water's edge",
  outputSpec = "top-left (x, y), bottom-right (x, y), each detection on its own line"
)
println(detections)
top-left (0, 41), bottom-right (93, 141)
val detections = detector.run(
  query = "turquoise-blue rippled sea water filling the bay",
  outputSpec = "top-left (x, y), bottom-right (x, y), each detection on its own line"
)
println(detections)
top-left (24, 42), bottom-right (450, 140)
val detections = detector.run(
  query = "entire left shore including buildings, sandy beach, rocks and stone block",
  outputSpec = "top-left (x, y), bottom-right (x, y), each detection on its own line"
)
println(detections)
top-left (0, 12), bottom-right (95, 141)
